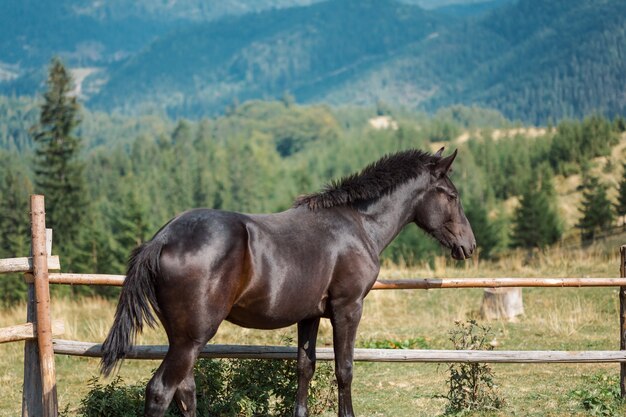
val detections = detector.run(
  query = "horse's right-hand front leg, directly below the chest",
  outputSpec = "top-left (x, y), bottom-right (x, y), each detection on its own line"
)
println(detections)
top-left (331, 300), bottom-right (363, 417)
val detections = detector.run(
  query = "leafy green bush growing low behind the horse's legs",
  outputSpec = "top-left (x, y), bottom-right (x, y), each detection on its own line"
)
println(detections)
top-left (69, 359), bottom-right (336, 417)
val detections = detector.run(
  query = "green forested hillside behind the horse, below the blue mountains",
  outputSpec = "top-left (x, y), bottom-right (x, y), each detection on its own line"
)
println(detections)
top-left (0, 97), bottom-right (626, 272)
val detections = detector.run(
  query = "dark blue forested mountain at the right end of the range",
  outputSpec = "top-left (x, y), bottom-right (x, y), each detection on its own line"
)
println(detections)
top-left (468, 0), bottom-right (626, 121)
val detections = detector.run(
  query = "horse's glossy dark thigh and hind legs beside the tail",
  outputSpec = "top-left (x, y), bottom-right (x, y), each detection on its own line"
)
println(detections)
top-left (150, 228), bottom-right (245, 417)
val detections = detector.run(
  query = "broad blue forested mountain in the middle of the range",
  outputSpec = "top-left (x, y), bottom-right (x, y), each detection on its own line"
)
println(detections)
top-left (93, 0), bottom-right (441, 114)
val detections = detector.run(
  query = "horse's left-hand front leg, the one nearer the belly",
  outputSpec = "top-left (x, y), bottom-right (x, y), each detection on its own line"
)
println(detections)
top-left (293, 317), bottom-right (320, 417)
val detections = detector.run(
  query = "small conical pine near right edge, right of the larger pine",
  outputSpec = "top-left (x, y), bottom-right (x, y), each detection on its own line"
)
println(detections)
top-left (577, 177), bottom-right (615, 243)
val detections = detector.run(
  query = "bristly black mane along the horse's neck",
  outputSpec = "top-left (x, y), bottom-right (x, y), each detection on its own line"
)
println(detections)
top-left (294, 149), bottom-right (440, 210)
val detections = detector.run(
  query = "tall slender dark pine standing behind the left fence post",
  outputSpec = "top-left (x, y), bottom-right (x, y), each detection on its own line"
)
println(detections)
top-left (32, 58), bottom-right (88, 264)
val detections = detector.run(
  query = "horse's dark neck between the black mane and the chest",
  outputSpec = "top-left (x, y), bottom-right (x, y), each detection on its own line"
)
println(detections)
top-left (360, 178), bottom-right (427, 254)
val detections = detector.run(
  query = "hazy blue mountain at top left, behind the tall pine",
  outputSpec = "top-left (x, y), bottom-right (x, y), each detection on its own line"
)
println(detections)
top-left (0, 0), bottom-right (319, 90)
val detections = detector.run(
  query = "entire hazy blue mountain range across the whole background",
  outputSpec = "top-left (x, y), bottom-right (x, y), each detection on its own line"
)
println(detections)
top-left (0, 0), bottom-right (626, 123)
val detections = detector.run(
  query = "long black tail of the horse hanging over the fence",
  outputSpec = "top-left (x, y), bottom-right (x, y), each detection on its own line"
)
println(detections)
top-left (100, 239), bottom-right (163, 376)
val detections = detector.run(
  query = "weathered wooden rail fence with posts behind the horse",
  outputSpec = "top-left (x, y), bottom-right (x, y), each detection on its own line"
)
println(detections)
top-left (0, 195), bottom-right (626, 417)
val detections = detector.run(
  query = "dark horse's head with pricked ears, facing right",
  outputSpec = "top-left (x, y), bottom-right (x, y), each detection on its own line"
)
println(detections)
top-left (415, 148), bottom-right (476, 259)
